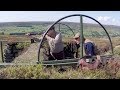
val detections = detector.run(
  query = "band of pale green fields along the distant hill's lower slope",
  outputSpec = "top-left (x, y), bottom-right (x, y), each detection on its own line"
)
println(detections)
top-left (0, 23), bottom-right (120, 37)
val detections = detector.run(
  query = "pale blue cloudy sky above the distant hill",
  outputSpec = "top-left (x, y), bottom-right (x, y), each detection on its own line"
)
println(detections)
top-left (0, 11), bottom-right (120, 26)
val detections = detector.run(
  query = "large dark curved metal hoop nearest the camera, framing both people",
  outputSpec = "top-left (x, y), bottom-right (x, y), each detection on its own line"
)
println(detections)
top-left (38, 14), bottom-right (113, 62)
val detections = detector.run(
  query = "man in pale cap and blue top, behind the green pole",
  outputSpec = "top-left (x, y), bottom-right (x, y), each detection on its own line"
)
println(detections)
top-left (64, 33), bottom-right (96, 58)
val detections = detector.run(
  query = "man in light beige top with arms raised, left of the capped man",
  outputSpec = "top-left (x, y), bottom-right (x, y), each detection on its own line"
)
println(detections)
top-left (45, 27), bottom-right (64, 60)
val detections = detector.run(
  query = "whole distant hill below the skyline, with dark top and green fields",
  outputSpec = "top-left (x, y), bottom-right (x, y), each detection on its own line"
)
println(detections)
top-left (0, 21), bottom-right (120, 36)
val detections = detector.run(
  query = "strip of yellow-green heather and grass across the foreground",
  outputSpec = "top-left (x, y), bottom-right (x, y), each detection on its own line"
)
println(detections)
top-left (0, 65), bottom-right (120, 79)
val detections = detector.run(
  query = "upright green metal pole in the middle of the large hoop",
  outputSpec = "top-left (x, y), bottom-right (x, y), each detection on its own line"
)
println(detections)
top-left (80, 16), bottom-right (83, 58)
